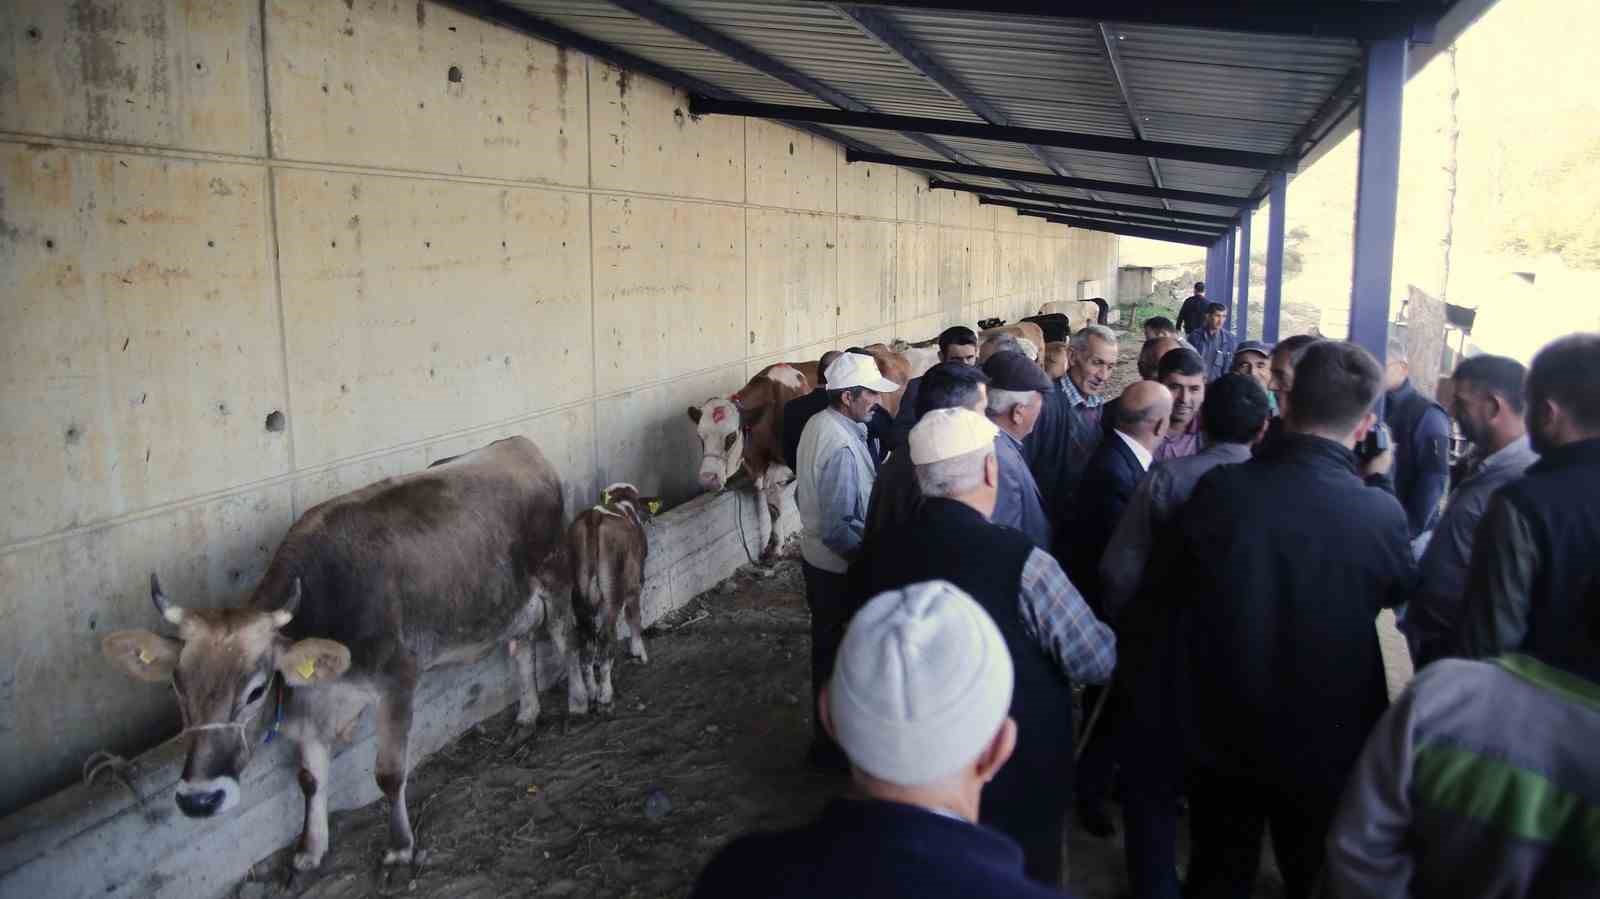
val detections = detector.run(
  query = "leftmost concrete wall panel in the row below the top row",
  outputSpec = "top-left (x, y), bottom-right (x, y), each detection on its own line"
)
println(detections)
top-left (0, 144), bottom-right (288, 542)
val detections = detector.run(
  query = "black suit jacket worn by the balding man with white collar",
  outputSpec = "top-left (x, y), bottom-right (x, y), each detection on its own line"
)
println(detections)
top-left (1056, 432), bottom-right (1144, 604)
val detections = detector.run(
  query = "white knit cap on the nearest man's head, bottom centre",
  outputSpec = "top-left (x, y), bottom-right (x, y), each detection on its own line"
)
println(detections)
top-left (827, 581), bottom-right (1013, 787)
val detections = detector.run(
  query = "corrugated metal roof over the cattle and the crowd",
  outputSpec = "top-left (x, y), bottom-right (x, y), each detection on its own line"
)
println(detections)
top-left (483, 0), bottom-right (1485, 236)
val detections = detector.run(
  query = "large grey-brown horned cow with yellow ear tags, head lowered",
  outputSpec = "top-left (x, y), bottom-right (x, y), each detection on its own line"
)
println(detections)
top-left (102, 437), bottom-right (582, 870)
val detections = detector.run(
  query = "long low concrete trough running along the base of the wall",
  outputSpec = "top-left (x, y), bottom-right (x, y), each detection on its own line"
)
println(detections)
top-left (0, 491), bottom-right (798, 899)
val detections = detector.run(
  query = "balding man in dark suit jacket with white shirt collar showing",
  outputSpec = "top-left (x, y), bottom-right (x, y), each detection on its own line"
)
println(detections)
top-left (1056, 381), bottom-right (1173, 837)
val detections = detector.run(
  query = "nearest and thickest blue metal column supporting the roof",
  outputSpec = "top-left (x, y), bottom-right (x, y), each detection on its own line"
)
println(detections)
top-left (1350, 37), bottom-right (1408, 363)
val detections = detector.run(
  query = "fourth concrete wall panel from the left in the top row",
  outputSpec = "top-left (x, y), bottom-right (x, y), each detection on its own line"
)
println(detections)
top-left (744, 118), bottom-right (845, 213)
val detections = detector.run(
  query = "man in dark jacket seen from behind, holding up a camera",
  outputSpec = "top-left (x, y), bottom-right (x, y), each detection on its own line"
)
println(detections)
top-left (1170, 341), bottom-right (1416, 897)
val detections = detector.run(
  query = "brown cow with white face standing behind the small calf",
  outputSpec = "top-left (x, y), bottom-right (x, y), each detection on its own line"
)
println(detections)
top-left (688, 362), bottom-right (816, 557)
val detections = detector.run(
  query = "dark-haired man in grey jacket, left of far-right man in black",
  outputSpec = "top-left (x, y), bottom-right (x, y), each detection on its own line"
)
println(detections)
top-left (1400, 355), bottom-right (1539, 669)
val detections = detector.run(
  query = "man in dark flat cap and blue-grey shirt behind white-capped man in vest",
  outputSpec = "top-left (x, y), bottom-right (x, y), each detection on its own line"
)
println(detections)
top-left (984, 352), bottom-right (1054, 549)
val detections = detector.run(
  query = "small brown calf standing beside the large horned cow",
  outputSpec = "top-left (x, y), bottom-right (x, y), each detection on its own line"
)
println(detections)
top-left (566, 483), bottom-right (661, 705)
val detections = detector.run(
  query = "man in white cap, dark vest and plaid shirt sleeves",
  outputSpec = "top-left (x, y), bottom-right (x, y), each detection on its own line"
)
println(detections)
top-left (850, 410), bottom-right (1117, 886)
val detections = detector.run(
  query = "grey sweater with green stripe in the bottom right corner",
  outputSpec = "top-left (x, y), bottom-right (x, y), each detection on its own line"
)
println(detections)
top-left (1323, 656), bottom-right (1600, 899)
